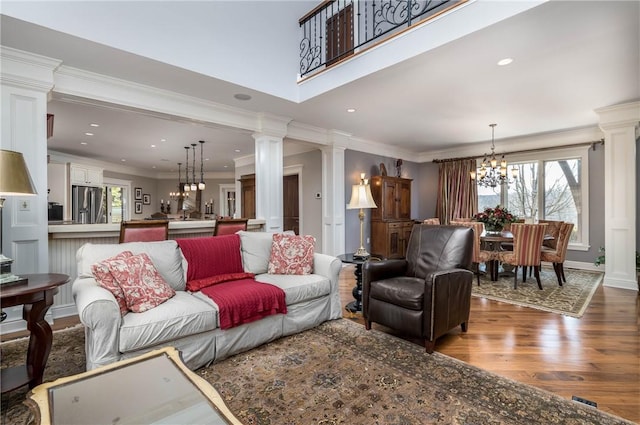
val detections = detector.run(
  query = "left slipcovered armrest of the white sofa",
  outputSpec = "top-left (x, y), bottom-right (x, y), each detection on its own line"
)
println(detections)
top-left (72, 277), bottom-right (122, 370)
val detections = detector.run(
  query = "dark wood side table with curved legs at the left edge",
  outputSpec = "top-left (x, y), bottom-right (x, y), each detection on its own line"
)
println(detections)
top-left (0, 273), bottom-right (69, 394)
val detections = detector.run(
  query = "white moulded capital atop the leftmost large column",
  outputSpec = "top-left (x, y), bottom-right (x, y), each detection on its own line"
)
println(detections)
top-left (0, 46), bottom-right (62, 93)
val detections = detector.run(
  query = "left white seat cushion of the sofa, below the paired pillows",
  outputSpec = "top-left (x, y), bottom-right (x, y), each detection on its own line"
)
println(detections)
top-left (119, 291), bottom-right (218, 353)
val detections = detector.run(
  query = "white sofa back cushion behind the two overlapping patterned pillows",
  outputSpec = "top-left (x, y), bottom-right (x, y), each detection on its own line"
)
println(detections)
top-left (76, 240), bottom-right (185, 291)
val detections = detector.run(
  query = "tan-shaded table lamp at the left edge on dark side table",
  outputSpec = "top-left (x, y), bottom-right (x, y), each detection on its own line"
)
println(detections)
top-left (0, 149), bottom-right (36, 284)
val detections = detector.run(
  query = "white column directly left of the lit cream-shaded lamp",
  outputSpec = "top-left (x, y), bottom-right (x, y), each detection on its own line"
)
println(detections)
top-left (321, 131), bottom-right (349, 255)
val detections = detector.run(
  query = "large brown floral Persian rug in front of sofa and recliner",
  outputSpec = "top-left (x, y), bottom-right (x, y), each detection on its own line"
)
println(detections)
top-left (2, 319), bottom-right (631, 425)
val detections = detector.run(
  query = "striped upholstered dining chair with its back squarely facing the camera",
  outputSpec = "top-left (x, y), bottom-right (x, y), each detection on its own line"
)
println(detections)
top-left (498, 223), bottom-right (547, 289)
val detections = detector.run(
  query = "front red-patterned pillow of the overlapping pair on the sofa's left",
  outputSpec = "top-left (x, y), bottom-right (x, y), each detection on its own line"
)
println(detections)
top-left (109, 253), bottom-right (176, 313)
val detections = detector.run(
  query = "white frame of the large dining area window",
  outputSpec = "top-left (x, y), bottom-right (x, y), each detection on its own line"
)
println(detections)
top-left (476, 145), bottom-right (591, 251)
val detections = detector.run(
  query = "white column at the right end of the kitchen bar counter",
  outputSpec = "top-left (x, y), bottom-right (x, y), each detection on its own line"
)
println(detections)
top-left (253, 115), bottom-right (289, 232)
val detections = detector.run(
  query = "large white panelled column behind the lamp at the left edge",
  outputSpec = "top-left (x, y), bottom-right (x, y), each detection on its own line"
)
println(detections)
top-left (0, 46), bottom-right (59, 333)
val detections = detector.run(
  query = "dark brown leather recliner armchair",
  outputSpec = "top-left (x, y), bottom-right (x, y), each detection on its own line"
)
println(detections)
top-left (362, 224), bottom-right (474, 353)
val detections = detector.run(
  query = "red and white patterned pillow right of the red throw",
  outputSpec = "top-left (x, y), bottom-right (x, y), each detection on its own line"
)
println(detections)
top-left (268, 233), bottom-right (316, 274)
